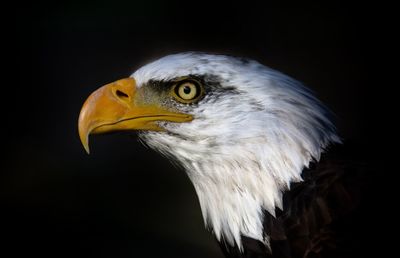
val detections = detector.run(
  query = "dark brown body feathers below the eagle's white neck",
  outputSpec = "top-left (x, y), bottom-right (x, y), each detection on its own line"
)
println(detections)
top-left (220, 143), bottom-right (364, 258)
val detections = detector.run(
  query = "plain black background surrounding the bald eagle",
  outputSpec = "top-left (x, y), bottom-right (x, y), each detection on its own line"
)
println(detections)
top-left (1, 1), bottom-right (394, 257)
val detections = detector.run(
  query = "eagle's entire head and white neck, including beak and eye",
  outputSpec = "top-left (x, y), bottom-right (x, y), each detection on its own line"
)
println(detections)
top-left (79, 53), bottom-right (339, 247)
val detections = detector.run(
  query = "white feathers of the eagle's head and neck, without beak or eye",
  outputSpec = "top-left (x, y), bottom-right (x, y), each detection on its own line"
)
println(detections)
top-left (131, 53), bottom-right (340, 248)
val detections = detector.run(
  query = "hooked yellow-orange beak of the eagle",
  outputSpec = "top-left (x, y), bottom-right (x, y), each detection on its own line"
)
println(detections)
top-left (78, 78), bottom-right (193, 153)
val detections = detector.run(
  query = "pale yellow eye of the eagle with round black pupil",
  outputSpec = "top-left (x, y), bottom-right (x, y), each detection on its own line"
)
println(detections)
top-left (173, 81), bottom-right (202, 103)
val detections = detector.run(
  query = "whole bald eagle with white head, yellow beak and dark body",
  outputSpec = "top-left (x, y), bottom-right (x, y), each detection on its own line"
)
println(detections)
top-left (78, 52), bottom-right (360, 257)
